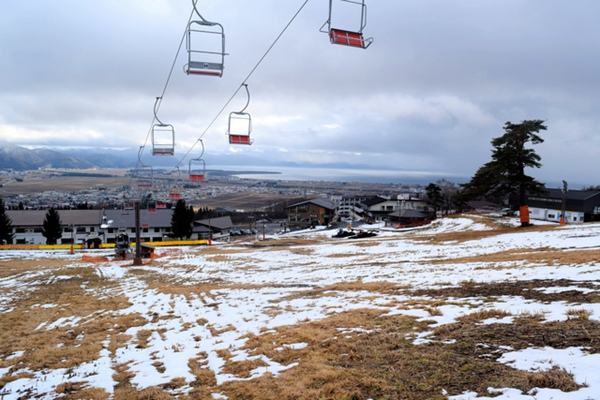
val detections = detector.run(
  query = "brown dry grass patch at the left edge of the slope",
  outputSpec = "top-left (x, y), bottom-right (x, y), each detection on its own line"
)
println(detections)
top-left (0, 268), bottom-right (145, 376)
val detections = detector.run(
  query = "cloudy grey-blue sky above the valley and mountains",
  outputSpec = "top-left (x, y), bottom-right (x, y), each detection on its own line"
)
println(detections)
top-left (0, 0), bottom-right (600, 184)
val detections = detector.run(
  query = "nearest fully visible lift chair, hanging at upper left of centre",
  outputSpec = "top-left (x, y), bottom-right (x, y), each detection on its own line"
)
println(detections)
top-left (183, 0), bottom-right (227, 77)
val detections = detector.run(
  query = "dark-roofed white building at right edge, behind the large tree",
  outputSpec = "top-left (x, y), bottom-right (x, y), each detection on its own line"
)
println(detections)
top-left (528, 189), bottom-right (600, 223)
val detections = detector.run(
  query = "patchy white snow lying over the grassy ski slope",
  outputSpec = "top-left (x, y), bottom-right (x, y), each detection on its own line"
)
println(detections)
top-left (0, 217), bottom-right (600, 400)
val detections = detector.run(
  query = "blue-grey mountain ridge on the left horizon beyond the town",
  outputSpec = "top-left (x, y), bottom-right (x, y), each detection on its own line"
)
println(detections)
top-left (0, 144), bottom-right (135, 170)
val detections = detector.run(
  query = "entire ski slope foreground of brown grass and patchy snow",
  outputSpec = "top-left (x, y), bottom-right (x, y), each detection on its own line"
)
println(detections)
top-left (0, 215), bottom-right (600, 400)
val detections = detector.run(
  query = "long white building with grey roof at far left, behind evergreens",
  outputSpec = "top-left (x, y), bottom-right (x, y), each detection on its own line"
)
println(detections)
top-left (6, 210), bottom-right (102, 244)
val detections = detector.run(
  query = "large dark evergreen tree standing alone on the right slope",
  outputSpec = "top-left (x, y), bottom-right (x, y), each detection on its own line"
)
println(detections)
top-left (464, 120), bottom-right (547, 226)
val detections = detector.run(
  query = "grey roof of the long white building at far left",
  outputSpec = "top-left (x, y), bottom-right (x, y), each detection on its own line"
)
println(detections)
top-left (6, 210), bottom-right (102, 226)
